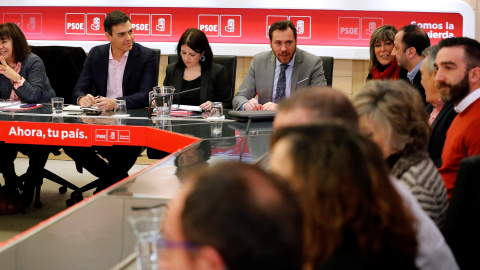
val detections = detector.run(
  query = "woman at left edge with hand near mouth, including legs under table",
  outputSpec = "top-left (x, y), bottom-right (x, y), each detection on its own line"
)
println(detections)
top-left (0, 23), bottom-right (55, 211)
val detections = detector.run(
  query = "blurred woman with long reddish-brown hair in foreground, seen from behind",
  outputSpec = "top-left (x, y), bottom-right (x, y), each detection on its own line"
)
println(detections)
top-left (271, 124), bottom-right (418, 270)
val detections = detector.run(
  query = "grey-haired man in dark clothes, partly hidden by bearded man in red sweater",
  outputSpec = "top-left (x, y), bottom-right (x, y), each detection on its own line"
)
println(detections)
top-left (420, 45), bottom-right (457, 168)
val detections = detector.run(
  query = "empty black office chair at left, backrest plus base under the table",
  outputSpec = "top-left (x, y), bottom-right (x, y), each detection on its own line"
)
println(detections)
top-left (30, 46), bottom-right (87, 208)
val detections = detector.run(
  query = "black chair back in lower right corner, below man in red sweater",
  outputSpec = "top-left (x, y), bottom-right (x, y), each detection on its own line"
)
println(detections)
top-left (442, 155), bottom-right (480, 269)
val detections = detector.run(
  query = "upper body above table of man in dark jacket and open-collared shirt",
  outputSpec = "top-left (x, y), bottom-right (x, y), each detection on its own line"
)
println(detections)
top-left (72, 11), bottom-right (156, 110)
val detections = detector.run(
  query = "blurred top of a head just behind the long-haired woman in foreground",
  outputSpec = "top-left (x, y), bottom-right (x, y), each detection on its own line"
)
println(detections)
top-left (273, 87), bottom-right (358, 130)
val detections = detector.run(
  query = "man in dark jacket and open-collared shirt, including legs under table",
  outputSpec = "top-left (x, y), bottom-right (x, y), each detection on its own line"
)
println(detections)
top-left (64, 11), bottom-right (156, 191)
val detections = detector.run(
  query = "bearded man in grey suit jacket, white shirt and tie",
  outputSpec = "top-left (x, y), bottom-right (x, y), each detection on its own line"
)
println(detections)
top-left (233, 21), bottom-right (327, 111)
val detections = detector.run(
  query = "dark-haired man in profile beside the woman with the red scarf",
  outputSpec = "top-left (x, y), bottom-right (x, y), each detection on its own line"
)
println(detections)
top-left (392, 24), bottom-right (430, 105)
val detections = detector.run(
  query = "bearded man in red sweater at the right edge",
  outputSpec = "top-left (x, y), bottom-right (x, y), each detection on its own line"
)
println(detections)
top-left (435, 37), bottom-right (480, 199)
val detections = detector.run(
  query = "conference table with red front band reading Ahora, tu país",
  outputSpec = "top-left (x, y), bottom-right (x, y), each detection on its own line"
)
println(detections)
top-left (0, 104), bottom-right (272, 270)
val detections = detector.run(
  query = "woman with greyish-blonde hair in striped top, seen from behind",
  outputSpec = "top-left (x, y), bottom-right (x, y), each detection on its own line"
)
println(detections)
top-left (353, 80), bottom-right (448, 227)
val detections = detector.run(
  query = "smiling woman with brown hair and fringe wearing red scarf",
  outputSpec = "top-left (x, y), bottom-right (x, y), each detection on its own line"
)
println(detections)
top-left (367, 25), bottom-right (407, 80)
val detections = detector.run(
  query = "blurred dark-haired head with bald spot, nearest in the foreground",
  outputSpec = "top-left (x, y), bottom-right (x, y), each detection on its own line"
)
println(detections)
top-left (182, 162), bottom-right (302, 270)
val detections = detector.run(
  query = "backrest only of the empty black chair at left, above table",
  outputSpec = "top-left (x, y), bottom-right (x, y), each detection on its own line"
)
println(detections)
top-left (30, 46), bottom-right (87, 104)
